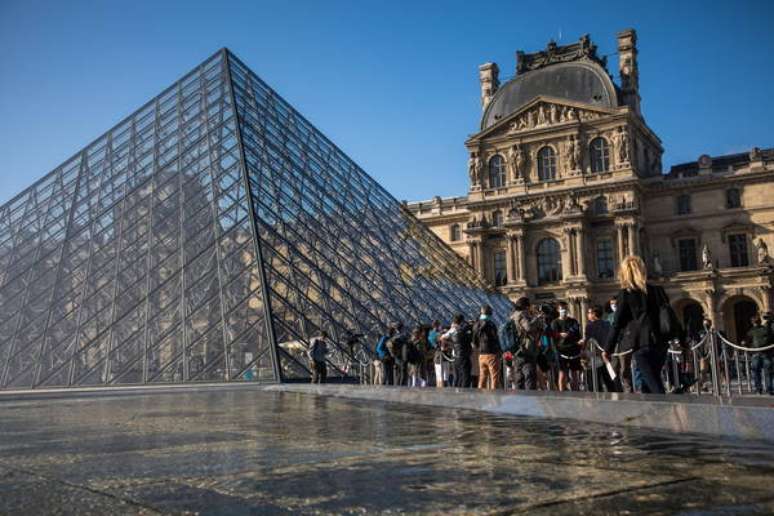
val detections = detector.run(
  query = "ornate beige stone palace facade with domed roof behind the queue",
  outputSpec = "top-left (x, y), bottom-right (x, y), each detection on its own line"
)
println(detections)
top-left (407, 29), bottom-right (774, 340)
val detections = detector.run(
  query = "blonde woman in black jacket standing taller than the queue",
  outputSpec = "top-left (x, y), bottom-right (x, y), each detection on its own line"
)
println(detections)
top-left (605, 256), bottom-right (669, 394)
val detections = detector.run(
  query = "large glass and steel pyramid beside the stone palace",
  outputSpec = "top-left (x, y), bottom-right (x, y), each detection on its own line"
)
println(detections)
top-left (0, 49), bottom-right (510, 389)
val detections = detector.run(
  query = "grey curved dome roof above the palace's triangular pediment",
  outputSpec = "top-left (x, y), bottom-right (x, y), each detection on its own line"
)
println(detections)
top-left (481, 61), bottom-right (618, 130)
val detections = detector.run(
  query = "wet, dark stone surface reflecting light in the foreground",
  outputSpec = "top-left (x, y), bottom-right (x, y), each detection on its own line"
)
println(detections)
top-left (0, 389), bottom-right (774, 514)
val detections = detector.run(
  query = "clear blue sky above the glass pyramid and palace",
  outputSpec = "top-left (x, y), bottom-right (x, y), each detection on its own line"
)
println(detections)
top-left (0, 0), bottom-right (774, 206)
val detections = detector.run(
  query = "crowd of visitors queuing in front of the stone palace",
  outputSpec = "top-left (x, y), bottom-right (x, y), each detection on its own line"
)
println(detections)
top-left (310, 256), bottom-right (774, 394)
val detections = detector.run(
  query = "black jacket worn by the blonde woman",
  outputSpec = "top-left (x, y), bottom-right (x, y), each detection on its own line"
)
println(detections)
top-left (604, 284), bottom-right (668, 353)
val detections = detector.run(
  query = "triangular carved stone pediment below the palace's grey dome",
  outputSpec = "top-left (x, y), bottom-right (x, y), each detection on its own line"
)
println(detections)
top-left (468, 96), bottom-right (615, 142)
